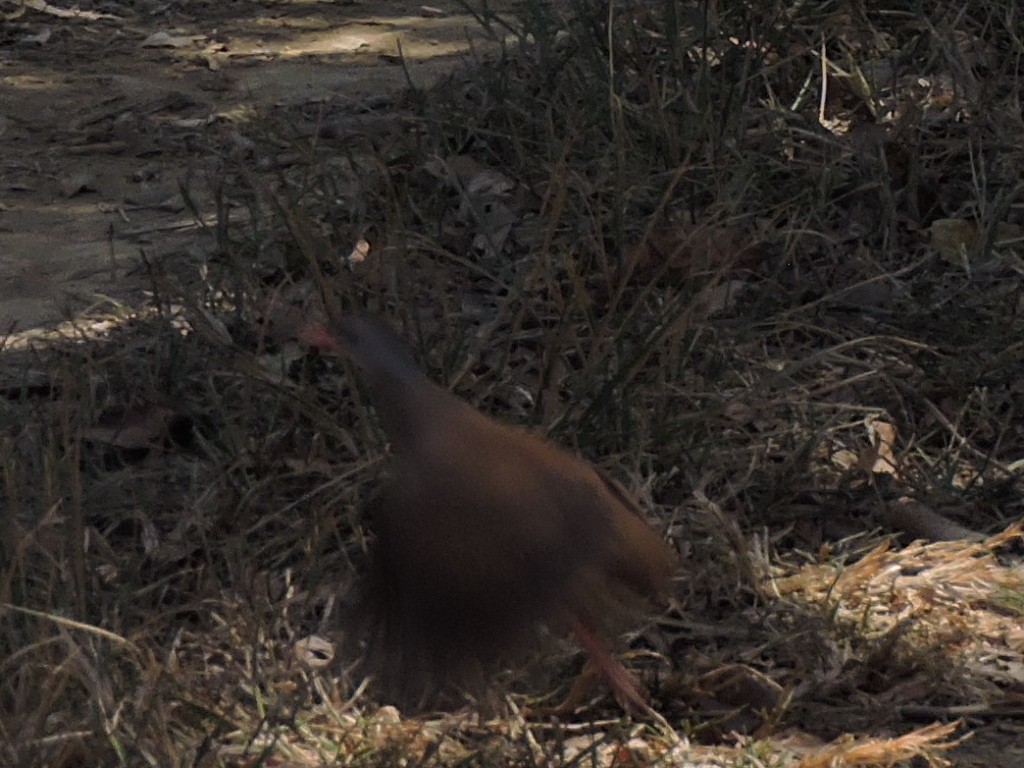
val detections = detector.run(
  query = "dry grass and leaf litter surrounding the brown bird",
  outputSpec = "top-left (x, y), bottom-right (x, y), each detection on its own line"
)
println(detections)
top-left (0, 0), bottom-right (1024, 768)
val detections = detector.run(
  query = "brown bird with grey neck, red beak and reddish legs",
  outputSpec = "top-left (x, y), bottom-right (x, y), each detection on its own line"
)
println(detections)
top-left (300, 314), bottom-right (675, 712)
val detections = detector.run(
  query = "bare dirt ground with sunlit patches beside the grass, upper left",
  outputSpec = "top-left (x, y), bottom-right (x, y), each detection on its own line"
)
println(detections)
top-left (0, 0), bottom-right (501, 332)
